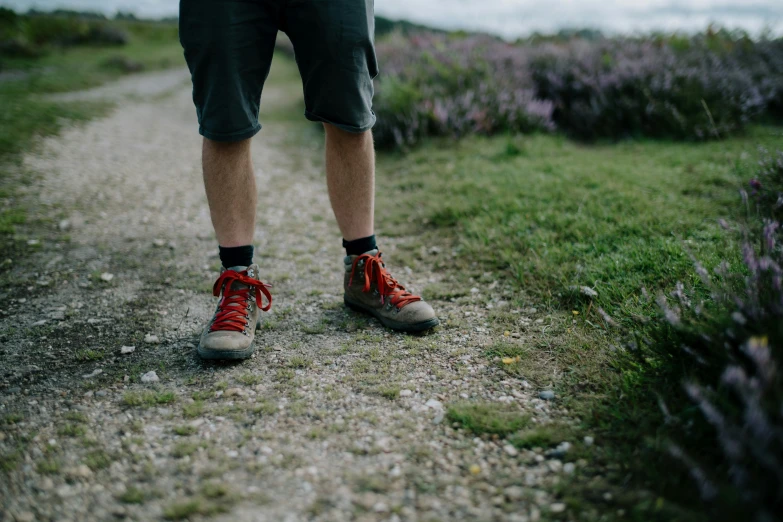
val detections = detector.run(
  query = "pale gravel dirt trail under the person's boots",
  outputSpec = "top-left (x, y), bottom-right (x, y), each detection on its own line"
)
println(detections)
top-left (0, 65), bottom-right (569, 522)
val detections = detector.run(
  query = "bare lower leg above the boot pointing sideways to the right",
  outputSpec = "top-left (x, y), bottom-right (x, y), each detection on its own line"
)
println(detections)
top-left (324, 124), bottom-right (375, 241)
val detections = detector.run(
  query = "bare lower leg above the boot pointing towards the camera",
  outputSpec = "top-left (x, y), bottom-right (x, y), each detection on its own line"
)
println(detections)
top-left (201, 138), bottom-right (258, 247)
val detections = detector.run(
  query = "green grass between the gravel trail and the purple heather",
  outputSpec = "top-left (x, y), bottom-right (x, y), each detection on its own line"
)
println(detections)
top-left (378, 118), bottom-right (783, 519)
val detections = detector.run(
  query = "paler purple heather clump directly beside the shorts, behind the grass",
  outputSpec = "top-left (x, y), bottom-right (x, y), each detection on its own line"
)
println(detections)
top-left (375, 33), bottom-right (554, 146)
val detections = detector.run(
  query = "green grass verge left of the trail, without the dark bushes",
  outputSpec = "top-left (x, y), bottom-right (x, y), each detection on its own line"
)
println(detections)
top-left (0, 17), bottom-right (184, 256)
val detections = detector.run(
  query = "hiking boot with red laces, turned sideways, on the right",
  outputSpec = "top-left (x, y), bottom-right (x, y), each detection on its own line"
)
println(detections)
top-left (344, 250), bottom-right (438, 332)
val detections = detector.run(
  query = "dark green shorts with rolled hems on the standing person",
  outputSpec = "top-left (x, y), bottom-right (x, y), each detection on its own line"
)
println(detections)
top-left (179, 0), bottom-right (378, 141)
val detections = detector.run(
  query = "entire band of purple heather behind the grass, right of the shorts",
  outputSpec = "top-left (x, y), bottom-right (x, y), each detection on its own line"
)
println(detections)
top-left (375, 33), bottom-right (783, 146)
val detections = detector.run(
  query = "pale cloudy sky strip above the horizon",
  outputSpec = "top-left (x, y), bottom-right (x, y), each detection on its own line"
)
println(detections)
top-left (0, 0), bottom-right (783, 38)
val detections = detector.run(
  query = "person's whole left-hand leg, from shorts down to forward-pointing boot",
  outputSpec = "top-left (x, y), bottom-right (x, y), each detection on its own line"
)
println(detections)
top-left (179, 0), bottom-right (282, 359)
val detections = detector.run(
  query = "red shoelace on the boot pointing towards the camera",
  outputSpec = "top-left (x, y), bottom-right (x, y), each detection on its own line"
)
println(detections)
top-left (209, 270), bottom-right (272, 332)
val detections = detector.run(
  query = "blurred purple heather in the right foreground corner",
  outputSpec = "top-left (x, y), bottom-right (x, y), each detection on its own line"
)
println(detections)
top-left (658, 151), bottom-right (783, 522)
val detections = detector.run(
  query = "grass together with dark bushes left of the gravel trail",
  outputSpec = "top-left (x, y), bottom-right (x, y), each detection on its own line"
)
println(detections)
top-left (0, 7), bottom-right (184, 259)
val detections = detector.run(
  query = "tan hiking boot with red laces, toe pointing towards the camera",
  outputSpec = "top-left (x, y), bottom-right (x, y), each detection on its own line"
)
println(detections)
top-left (198, 265), bottom-right (272, 359)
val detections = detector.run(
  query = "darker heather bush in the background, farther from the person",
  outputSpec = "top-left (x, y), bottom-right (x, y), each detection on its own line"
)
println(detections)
top-left (533, 39), bottom-right (769, 140)
